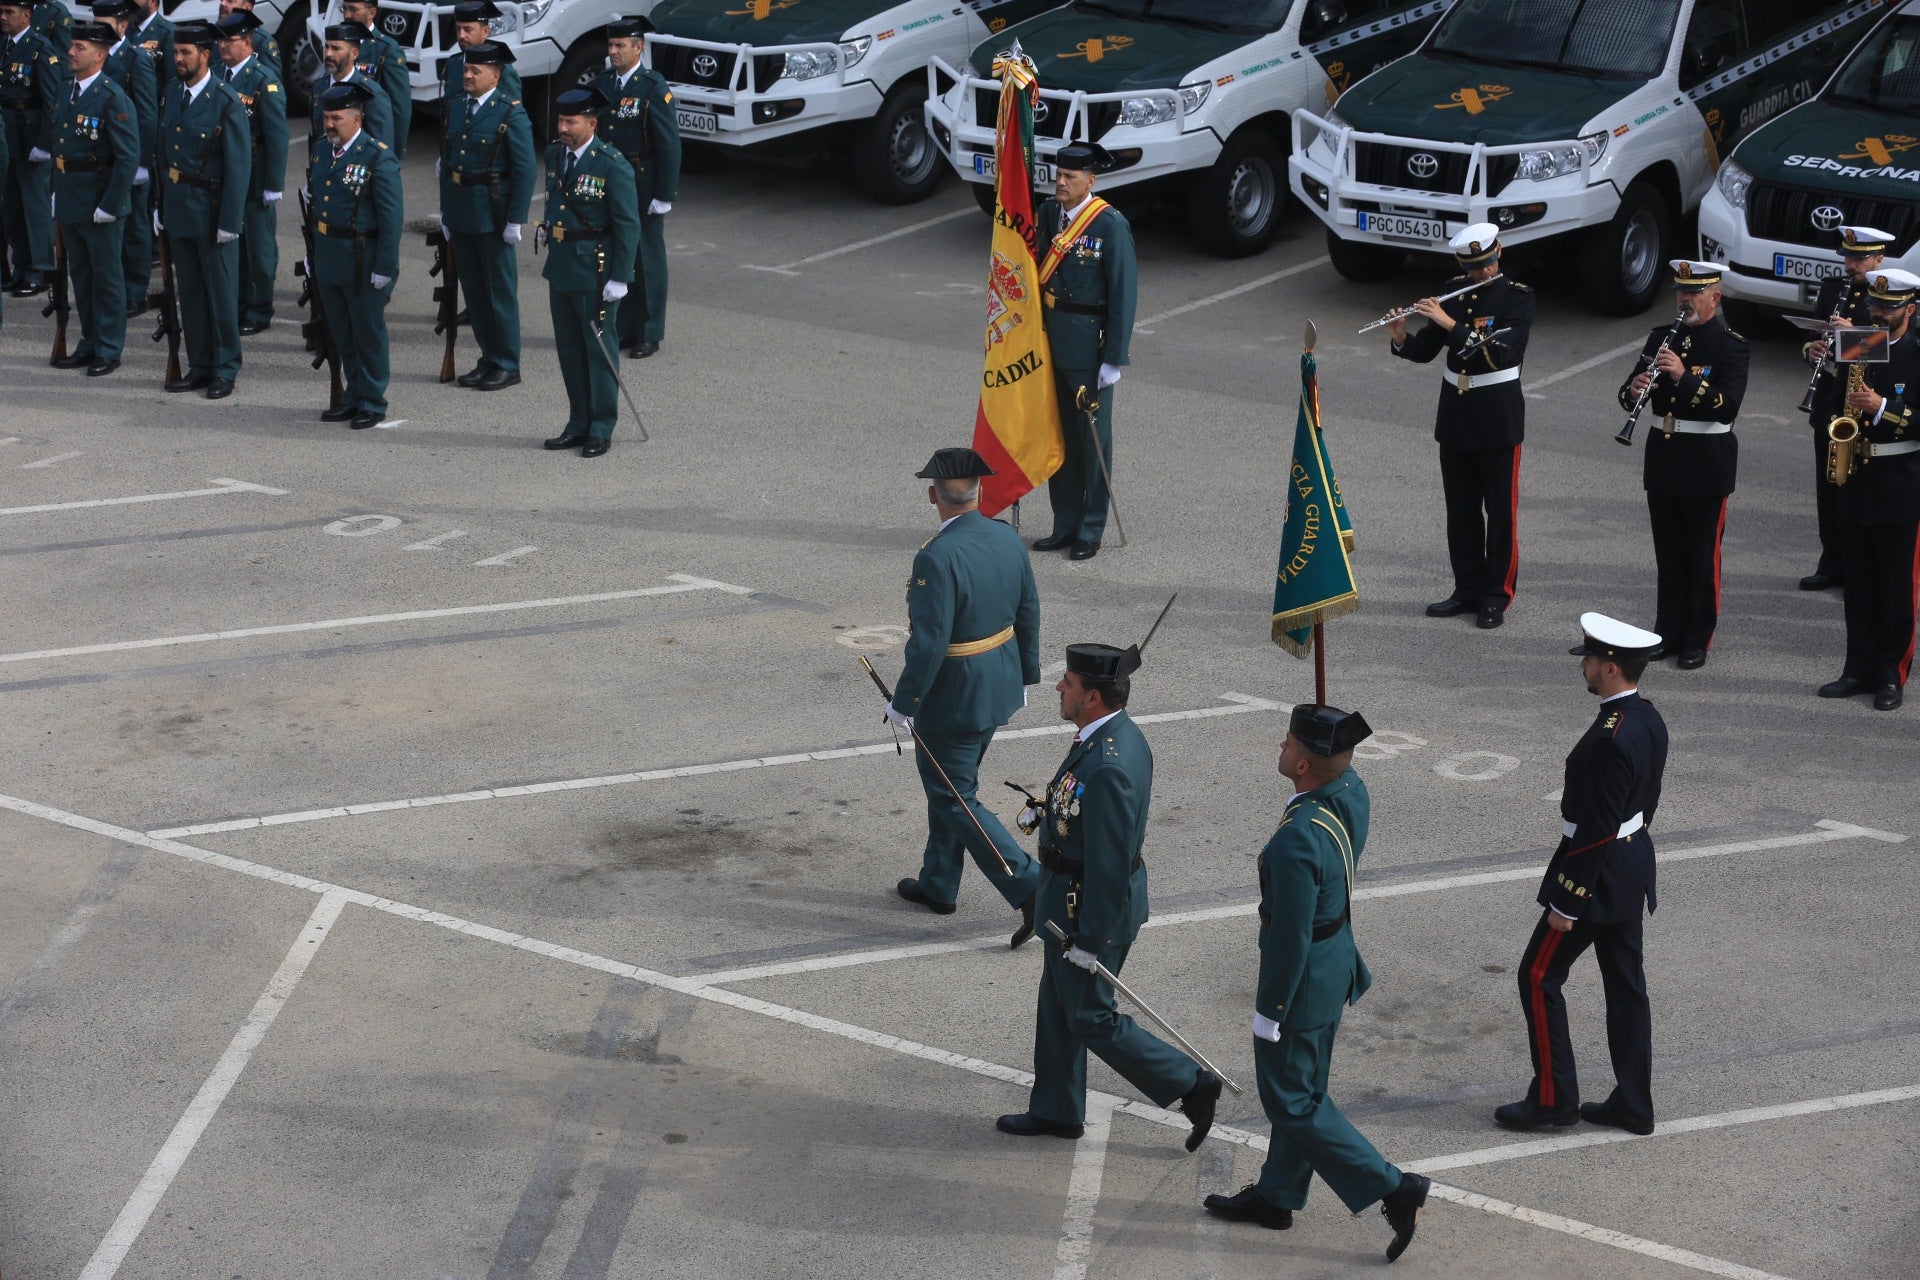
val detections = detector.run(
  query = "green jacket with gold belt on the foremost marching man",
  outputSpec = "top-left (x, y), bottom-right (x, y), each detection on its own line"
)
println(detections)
top-left (893, 510), bottom-right (1041, 733)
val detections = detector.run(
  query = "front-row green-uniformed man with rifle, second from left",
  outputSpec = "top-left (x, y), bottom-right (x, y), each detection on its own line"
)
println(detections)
top-left (154, 23), bottom-right (253, 399)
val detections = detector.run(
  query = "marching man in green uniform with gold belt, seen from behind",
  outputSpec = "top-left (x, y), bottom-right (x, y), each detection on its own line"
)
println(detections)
top-left (887, 449), bottom-right (1041, 946)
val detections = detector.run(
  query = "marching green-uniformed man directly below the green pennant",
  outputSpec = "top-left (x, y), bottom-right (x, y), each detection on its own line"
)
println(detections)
top-left (1206, 702), bottom-right (1432, 1263)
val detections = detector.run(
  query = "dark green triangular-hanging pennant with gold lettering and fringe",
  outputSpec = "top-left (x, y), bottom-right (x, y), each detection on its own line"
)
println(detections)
top-left (1273, 351), bottom-right (1359, 658)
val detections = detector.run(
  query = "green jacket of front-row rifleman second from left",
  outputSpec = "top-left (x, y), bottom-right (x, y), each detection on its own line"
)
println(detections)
top-left (156, 73), bottom-right (253, 238)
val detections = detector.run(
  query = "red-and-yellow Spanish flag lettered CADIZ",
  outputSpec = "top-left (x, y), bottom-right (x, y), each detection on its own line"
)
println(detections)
top-left (973, 42), bottom-right (1066, 516)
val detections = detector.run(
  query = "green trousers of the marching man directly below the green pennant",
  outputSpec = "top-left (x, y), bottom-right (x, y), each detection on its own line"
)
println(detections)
top-left (1254, 1021), bottom-right (1400, 1213)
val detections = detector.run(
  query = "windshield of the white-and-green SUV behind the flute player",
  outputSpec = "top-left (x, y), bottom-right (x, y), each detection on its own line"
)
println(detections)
top-left (1427, 0), bottom-right (1680, 81)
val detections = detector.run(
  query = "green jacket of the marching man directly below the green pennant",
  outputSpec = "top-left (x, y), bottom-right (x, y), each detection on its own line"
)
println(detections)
top-left (1254, 770), bottom-right (1373, 1031)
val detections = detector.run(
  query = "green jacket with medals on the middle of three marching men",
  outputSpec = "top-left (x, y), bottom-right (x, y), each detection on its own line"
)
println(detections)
top-left (1039, 712), bottom-right (1154, 954)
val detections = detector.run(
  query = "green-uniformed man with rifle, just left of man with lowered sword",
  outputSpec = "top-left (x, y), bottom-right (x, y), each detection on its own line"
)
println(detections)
top-left (440, 42), bottom-right (534, 391)
